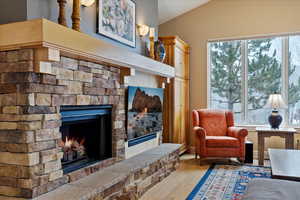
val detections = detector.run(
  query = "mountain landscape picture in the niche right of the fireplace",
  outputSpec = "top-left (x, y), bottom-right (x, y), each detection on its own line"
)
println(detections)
top-left (127, 86), bottom-right (164, 140)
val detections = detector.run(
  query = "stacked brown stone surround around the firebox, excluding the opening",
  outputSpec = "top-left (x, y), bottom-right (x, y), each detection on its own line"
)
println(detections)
top-left (0, 49), bottom-right (125, 199)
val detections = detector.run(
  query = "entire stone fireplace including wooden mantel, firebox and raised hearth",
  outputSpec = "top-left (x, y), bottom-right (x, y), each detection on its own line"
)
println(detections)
top-left (0, 19), bottom-right (180, 200)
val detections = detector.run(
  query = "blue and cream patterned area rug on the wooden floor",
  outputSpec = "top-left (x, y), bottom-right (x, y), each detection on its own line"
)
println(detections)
top-left (187, 165), bottom-right (271, 200)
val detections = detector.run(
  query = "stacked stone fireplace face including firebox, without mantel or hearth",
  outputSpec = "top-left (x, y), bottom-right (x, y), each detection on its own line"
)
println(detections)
top-left (0, 49), bottom-right (125, 198)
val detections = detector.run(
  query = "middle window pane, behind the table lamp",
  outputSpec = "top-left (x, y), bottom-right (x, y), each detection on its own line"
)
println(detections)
top-left (247, 38), bottom-right (282, 125)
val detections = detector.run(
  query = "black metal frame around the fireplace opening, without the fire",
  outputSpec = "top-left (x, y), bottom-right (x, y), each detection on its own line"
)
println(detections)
top-left (60, 105), bottom-right (112, 174)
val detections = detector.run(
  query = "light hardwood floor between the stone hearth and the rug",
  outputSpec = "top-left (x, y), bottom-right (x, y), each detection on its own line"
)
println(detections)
top-left (141, 154), bottom-right (270, 200)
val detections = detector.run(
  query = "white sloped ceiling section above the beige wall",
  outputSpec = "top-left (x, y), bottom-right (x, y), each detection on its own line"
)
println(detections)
top-left (158, 0), bottom-right (210, 24)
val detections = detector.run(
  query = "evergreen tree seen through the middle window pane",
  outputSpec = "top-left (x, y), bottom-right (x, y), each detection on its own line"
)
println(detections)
top-left (248, 39), bottom-right (281, 110)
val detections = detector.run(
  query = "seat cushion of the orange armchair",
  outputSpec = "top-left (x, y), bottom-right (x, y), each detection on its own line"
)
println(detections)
top-left (205, 136), bottom-right (240, 148)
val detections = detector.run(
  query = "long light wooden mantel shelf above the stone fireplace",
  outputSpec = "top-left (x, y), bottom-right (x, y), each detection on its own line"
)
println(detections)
top-left (0, 19), bottom-right (175, 78)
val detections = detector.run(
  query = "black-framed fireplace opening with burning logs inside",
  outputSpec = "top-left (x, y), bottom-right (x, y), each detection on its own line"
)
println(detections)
top-left (60, 106), bottom-right (112, 173)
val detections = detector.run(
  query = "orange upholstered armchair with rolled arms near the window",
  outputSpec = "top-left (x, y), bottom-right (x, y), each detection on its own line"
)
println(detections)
top-left (193, 109), bottom-right (248, 162)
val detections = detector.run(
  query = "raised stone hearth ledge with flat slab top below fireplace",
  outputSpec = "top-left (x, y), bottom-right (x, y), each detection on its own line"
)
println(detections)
top-left (35, 144), bottom-right (181, 200)
